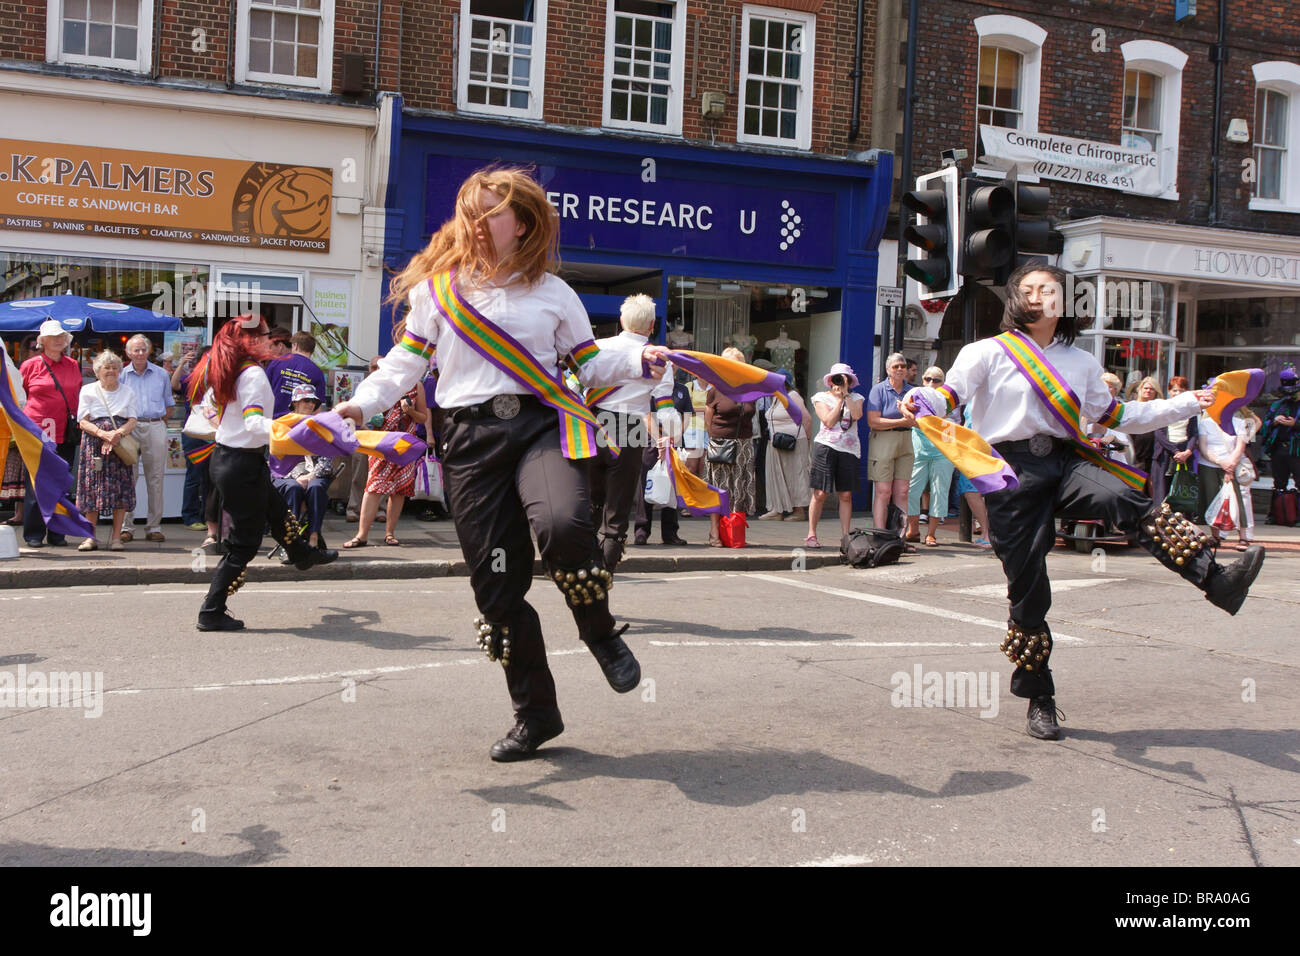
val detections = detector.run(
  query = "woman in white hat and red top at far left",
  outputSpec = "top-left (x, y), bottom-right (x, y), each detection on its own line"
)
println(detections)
top-left (20, 319), bottom-right (82, 548)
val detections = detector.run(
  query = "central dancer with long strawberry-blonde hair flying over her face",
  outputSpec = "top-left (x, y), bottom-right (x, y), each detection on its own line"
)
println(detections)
top-left (335, 168), bottom-right (667, 761)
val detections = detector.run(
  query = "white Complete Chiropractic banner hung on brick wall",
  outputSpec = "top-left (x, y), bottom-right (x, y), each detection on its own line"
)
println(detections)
top-left (979, 126), bottom-right (1169, 198)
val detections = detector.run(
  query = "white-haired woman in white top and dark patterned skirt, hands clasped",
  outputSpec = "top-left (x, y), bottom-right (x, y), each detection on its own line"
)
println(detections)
top-left (77, 349), bottom-right (135, 551)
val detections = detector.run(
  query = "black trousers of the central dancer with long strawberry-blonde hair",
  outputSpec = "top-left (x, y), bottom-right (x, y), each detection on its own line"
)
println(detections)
top-left (442, 403), bottom-right (614, 718)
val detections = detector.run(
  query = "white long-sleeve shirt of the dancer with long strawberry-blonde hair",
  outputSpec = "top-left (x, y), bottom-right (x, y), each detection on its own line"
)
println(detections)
top-left (352, 273), bottom-right (642, 418)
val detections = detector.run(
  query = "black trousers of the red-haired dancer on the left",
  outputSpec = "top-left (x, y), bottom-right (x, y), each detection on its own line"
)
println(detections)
top-left (199, 445), bottom-right (306, 614)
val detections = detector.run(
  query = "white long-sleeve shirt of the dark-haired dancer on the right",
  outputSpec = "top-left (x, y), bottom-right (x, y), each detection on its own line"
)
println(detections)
top-left (920, 338), bottom-right (1200, 445)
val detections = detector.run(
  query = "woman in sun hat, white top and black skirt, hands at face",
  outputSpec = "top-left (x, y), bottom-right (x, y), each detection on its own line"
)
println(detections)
top-left (803, 362), bottom-right (865, 548)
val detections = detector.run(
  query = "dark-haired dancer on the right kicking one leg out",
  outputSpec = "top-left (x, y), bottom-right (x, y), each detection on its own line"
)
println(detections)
top-left (900, 265), bottom-right (1264, 740)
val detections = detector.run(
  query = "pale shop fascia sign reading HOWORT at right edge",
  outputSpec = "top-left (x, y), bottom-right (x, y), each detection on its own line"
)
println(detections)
top-left (1102, 237), bottom-right (1300, 287)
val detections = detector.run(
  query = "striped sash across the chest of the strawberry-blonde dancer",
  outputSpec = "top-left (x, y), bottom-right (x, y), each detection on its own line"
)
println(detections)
top-left (429, 272), bottom-right (619, 459)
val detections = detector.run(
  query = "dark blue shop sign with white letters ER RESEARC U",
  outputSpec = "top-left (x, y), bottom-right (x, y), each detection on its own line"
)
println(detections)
top-left (425, 156), bottom-right (836, 268)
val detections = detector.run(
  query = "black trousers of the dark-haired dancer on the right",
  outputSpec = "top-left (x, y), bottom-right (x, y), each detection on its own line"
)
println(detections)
top-left (984, 446), bottom-right (1213, 697)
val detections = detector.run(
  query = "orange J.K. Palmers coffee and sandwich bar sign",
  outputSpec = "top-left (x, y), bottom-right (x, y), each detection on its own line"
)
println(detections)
top-left (0, 139), bottom-right (333, 252)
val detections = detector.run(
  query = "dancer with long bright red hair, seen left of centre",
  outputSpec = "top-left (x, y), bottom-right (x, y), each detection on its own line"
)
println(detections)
top-left (190, 315), bottom-right (338, 631)
